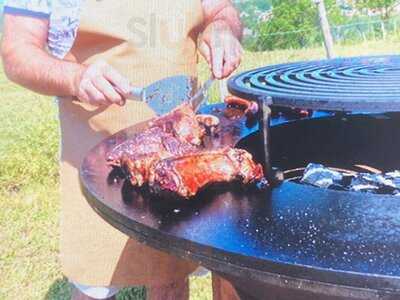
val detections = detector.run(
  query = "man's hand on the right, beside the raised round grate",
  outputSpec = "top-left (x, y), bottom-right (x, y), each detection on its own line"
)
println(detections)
top-left (199, 21), bottom-right (243, 79)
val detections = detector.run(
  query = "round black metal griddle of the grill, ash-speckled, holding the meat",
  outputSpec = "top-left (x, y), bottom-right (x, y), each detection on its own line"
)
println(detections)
top-left (81, 103), bottom-right (400, 299)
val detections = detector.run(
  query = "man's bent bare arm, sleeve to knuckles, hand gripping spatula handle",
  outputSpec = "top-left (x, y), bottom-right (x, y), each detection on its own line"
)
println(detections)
top-left (1, 14), bottom-right (129, 105)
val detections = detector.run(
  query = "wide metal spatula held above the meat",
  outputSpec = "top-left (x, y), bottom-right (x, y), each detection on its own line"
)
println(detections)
top-left (127, 75), bottom-right (197, 116)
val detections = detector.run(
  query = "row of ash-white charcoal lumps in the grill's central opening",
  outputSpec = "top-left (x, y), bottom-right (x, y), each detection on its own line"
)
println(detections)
top-left (300, 163), bottom-right (400, 196)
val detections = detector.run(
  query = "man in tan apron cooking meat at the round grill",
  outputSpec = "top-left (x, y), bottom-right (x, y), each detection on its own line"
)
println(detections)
top-left (1, 0), bottom-right (242, 300)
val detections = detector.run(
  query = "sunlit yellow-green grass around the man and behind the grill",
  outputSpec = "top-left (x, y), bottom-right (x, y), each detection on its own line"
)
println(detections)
top-left (0, 40), bottom-right (400, 300)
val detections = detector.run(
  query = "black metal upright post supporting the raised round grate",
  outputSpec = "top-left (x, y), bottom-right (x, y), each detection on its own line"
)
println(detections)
top-left (260, 101), bottom-right (284, 186)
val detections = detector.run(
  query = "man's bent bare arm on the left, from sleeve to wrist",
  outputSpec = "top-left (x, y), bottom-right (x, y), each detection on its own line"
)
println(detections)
top-left (1, 14), bottom-right (83, 96)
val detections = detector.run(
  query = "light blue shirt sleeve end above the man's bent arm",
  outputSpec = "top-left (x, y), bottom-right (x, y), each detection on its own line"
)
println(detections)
top-left (3, 0), bottom-right (51, 19)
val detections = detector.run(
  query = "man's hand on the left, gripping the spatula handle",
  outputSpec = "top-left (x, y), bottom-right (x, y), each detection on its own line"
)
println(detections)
top-left (74, 61), bottom-right (130, 106)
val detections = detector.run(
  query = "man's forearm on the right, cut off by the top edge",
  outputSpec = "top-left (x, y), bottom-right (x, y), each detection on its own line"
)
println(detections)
top-left (202, 0), bottom-right (243, 40)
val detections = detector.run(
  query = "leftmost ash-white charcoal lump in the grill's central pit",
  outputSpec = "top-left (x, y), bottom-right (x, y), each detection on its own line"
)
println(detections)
top-left (301, 164), bottom-right (343, 189)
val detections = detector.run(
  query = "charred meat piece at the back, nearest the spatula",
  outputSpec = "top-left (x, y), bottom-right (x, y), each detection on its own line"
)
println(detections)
top-left (106, 105), bottom-right (205, 186)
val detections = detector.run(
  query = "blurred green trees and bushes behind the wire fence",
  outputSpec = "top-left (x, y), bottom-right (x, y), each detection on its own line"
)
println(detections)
top-left (235, 0), bottom-right (400, 51)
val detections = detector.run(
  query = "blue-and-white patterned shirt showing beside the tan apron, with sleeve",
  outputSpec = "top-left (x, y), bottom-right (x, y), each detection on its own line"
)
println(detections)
top-left (4, 0), bottom-right (83, 58)
